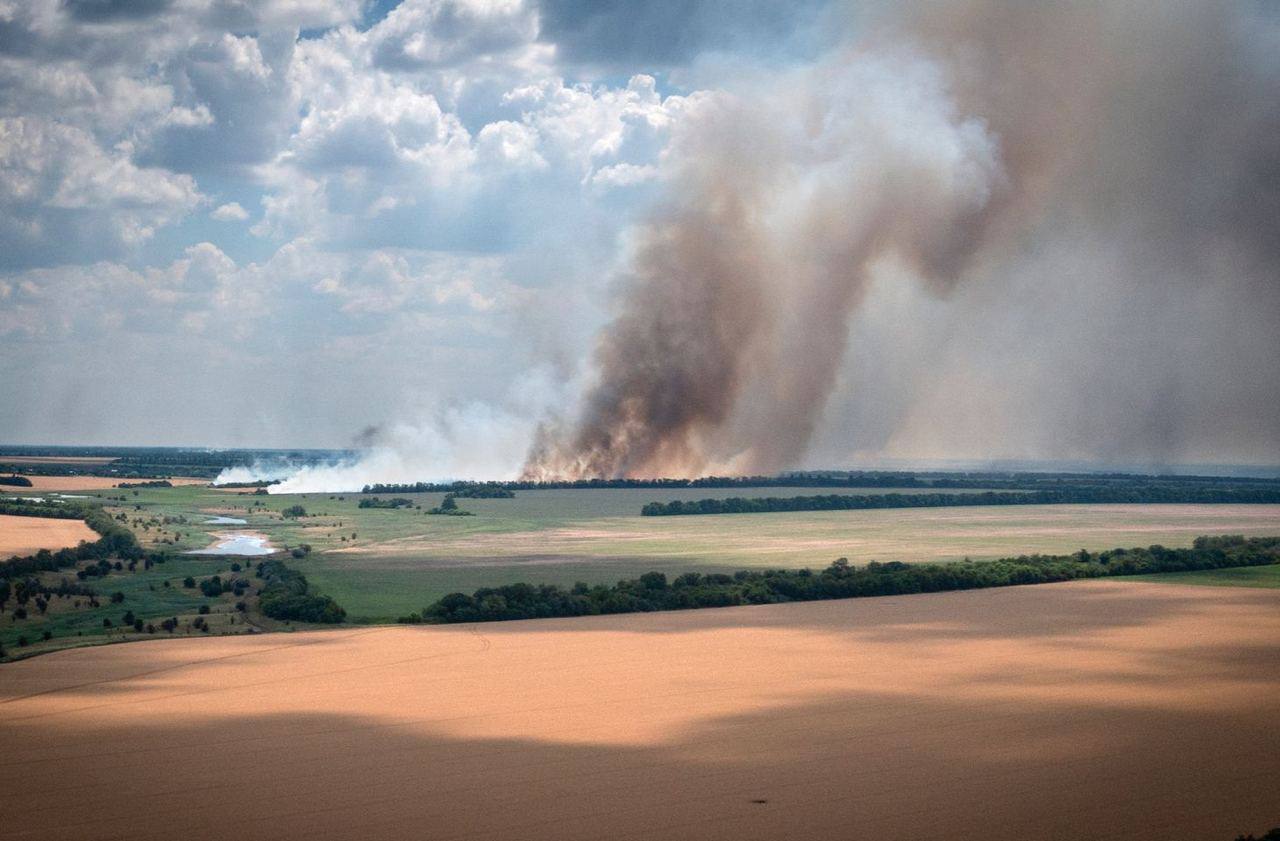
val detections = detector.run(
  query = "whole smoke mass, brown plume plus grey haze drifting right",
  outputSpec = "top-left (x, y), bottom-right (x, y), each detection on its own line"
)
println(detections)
top-left (525, 0), bottom-right (1280, 477)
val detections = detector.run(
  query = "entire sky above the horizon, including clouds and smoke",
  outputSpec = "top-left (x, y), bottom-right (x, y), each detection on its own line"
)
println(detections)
top-left (0, 0), bottom-right (1280, 479)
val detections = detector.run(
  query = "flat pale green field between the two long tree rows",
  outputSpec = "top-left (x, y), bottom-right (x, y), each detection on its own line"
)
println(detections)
top-left (7, 486), bottom-right (1280, 621)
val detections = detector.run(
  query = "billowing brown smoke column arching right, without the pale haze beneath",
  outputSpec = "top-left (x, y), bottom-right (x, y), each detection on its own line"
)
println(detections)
top-left (525, 0), bottom-right (1280, 477)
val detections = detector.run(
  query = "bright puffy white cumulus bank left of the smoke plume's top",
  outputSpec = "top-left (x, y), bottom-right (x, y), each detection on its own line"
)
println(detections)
top-left (253, 17), bottom-right (696, 251)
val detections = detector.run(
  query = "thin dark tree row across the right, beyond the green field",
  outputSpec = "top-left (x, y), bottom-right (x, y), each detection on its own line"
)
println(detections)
top-left (640, 485), bottom-right (1280, 517)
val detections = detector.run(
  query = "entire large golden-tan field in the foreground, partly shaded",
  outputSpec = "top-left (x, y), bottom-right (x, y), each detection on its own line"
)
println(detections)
top-left (0, 581), bottom-right (1280, 841)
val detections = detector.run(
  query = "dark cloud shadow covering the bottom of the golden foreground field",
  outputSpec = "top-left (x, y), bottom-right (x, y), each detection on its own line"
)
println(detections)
top-left (0, 668), bottom-right (1280, 841)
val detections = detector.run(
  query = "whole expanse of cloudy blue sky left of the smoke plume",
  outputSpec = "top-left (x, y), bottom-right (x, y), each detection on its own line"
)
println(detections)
top-left (0, 0), bottom-right (696, 440)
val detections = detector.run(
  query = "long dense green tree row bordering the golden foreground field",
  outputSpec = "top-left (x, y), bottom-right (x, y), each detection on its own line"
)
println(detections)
top-left (401, 535), bottom-right (1280, 623)
